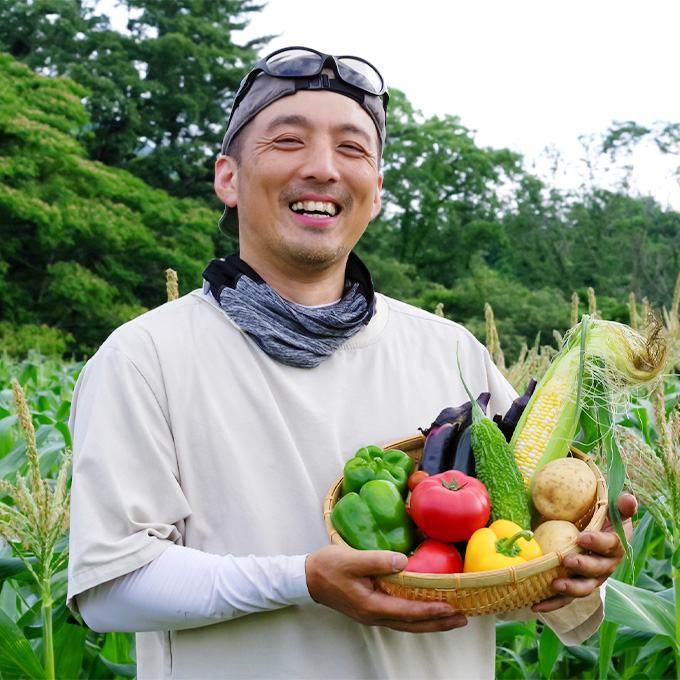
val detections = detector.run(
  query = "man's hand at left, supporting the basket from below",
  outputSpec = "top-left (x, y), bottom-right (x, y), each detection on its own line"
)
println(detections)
top-left (305, 545), bottom-right (467, 633)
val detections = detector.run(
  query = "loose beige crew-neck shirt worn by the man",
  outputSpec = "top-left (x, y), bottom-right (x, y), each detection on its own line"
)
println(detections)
top-left (68, 291), bottom-right (599, 680)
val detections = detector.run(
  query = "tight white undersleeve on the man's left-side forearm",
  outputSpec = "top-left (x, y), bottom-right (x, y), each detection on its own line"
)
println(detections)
top-left (76, 545), bottom-right (313, 632)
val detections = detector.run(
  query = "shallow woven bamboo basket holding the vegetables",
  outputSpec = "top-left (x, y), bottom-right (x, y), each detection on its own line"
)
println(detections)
top-left (324, 434), bottom-right (607, 616)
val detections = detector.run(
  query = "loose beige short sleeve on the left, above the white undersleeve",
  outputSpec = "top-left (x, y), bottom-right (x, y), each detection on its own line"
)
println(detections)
top-left (67, 344), bottom-right (191, 605)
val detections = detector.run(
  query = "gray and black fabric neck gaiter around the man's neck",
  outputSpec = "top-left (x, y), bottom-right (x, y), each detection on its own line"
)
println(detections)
top-left (203, 253), bottom-right (374, 368)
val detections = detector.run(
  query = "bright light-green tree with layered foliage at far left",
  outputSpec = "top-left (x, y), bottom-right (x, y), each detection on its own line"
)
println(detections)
top-left (0, 55), bottom-right (218, 352)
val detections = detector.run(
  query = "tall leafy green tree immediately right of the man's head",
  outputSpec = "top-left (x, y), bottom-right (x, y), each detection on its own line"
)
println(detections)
top-left (367, 90), bottom-right (521, 286)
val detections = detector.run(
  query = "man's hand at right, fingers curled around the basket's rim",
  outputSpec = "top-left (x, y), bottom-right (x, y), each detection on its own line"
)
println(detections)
top-left (531, 494), bottom-right (637, 613)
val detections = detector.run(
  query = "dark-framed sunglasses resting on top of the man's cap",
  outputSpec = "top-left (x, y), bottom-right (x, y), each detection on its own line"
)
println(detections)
top-left (227, 47), bottom-right (389, 127)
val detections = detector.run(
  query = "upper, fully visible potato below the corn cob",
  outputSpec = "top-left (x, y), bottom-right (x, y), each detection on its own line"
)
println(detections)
top-left (531, 458), bottom-right (597, 522)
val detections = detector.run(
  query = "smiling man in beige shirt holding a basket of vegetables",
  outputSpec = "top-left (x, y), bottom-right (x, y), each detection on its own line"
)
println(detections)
top-left (69, 48), bottom-right (635, 679)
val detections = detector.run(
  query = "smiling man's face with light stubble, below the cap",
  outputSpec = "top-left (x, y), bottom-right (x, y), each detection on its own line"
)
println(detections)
top-left (215, 91), bottom-right (382, 272)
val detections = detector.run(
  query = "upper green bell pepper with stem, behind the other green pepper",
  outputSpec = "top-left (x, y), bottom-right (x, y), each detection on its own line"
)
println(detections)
top-left (342, 446), bottom-right (413, 498)
